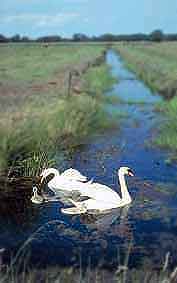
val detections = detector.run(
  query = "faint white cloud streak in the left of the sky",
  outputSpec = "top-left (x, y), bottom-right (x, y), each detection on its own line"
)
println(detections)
top-left (0, 12), bottom-right (80, 27)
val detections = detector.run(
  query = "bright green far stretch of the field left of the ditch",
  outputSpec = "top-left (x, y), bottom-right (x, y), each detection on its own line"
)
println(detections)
top-left (0, 44), bottom-right (104, 86)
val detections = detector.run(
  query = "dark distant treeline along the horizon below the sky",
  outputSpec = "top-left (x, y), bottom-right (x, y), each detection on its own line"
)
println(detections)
top-left (0, 30), bottom-right (177, 43)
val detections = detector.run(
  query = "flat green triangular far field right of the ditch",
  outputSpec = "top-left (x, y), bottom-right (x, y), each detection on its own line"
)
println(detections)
top-left (114, 43), bottom-right (177, 98)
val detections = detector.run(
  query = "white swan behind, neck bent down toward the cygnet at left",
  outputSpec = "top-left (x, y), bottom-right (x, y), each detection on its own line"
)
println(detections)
top-left (40, 168), bottom-right (91, 194)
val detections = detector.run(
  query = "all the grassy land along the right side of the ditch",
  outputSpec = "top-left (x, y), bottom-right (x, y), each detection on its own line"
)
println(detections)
top-left (114, 42), bottom-right (177, 156)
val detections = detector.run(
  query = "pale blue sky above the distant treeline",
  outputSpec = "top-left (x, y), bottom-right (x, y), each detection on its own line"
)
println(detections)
top-left (0, 0), bottom-right (177, 38)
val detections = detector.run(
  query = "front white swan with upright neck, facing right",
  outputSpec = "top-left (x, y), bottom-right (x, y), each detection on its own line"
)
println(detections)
top-left (61, 167), bottom-right (134, 215)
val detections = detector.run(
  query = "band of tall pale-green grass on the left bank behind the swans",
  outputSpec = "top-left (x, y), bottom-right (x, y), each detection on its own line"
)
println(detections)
top-left (0, 95), bottom-right (116, 175)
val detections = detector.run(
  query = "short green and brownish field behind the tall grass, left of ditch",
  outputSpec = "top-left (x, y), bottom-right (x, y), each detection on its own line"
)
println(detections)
top-left (0, 43), bottom-right (104, 110)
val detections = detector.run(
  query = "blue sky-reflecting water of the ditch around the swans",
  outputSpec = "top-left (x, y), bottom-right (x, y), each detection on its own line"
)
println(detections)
top-left (0, 52), bottom-right (177, 266)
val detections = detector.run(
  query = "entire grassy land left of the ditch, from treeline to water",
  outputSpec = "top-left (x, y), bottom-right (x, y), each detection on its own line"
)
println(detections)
top-left (0, 44), bottom-right (117, 172)
